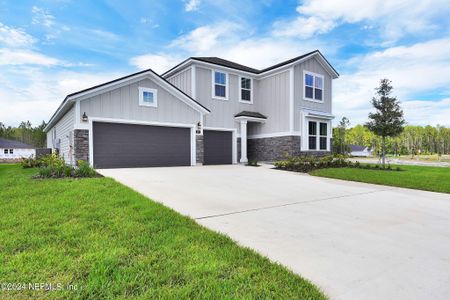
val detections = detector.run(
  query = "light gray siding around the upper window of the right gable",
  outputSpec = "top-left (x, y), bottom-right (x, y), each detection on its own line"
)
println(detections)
top-left (294, 58), bottom-right (332, 131)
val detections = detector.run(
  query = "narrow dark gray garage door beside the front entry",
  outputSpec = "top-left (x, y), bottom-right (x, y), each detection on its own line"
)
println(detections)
top-left (203, 130), bottom-right (233, 165)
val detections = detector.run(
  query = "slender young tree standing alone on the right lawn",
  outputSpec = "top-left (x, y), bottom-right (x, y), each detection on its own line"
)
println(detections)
top-left (366, 79), bottom-right (405, 168)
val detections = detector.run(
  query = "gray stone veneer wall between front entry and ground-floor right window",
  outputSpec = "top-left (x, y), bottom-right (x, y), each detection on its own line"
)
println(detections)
top-left (247, 136), bottom-right (300, 161)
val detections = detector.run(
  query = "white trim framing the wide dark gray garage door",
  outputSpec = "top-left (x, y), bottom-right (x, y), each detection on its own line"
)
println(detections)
top-left (89, 117), bottom-right (197, 166)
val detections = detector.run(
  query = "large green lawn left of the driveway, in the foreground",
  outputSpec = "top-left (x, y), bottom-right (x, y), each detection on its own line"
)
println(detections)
top-left (0, 165), bottom-right (325, 299)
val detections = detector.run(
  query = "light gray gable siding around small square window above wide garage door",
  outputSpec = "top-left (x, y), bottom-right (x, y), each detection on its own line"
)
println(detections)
top-left (80, 79), bottom-right (200, 124)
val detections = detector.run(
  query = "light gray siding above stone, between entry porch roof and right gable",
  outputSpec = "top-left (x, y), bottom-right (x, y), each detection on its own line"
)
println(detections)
top-left (248, 70), bottom-right (289, 135)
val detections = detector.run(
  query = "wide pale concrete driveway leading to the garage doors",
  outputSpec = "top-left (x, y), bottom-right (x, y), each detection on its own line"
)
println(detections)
top-left (99, 165), bottom-right (450, 299)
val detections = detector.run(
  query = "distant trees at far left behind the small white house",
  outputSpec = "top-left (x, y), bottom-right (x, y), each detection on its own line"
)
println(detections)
top-left (0, 121), bottom-right (47, 148)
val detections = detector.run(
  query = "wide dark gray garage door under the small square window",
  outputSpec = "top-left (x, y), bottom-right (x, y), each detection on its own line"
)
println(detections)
top-left (93, 122), bottom-right (191, 168)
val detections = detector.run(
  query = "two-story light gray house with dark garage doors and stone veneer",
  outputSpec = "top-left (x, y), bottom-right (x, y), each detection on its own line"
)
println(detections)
top-left (45, 50), bottom-right (339, 168)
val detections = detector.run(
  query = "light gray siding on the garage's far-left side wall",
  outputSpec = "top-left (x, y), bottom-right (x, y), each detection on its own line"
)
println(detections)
top-left (47, 106), bottom-right (75, 164)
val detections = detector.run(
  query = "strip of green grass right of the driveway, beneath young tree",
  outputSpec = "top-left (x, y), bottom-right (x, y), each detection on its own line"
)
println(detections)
top-left (310, 165), bottom-right (450, 193)
